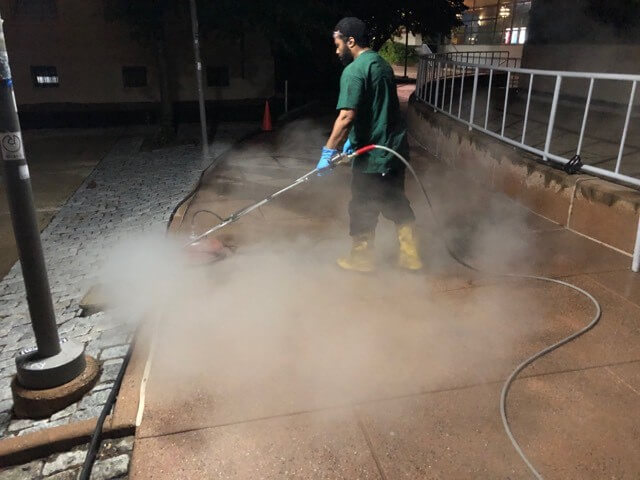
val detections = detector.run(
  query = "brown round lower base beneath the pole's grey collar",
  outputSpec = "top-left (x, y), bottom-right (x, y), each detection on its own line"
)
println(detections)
top-left (11, 356), bottom-right (100, 419)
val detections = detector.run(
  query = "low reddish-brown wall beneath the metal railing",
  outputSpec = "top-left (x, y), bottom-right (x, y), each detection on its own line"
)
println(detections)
top-left (407, 97), bottom-right (640, 254)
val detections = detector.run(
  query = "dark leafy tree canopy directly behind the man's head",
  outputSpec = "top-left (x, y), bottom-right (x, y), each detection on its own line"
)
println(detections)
top-left (198, 0), bottom-right (466, 94)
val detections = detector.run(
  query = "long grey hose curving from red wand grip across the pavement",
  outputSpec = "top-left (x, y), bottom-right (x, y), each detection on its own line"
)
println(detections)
top-left (362, 145), bottom-right (602, 480)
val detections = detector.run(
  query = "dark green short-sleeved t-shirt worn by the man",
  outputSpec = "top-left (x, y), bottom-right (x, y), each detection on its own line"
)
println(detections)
top-left (336, 50), bottom-right (408, 173)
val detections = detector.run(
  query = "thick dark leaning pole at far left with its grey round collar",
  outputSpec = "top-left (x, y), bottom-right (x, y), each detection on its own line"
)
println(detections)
top-left (0, 11), bottom-right (86, 393)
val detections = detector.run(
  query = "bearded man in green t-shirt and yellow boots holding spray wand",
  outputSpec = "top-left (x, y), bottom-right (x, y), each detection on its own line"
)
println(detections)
top-left (318, 17), bottom-right (422, 272)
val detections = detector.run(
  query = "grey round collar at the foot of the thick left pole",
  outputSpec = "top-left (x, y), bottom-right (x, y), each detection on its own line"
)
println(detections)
top-left (16, 340), bottom-right (86, 390)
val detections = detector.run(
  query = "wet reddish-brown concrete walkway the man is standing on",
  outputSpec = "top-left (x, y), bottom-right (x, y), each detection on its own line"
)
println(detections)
top-left (130, 119), bottom-right (640, 480)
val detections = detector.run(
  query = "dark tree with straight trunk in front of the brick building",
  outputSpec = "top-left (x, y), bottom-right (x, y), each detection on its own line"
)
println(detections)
top-left (105, 0), bottom-right (180, 142)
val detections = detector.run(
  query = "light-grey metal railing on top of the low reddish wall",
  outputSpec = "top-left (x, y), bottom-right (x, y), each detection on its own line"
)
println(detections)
top-left (416, 52), bottom-right (640, 187)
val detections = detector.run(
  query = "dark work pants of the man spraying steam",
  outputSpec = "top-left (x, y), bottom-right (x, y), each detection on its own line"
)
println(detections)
top-left (349, 168), bottom-right (415, 237)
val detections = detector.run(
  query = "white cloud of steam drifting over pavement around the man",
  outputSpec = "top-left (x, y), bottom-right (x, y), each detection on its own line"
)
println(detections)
top-left (95, 122), bottom-right (545, 432)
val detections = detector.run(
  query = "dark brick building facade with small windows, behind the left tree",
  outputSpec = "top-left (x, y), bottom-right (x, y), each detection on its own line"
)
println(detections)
top-left (0, 0), bottom-right (274, 125)
